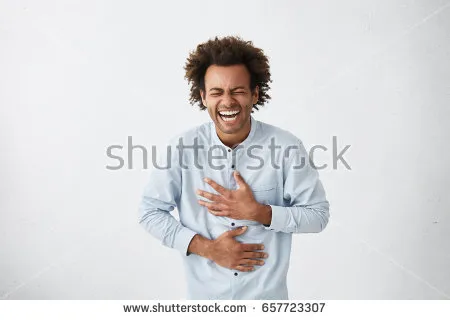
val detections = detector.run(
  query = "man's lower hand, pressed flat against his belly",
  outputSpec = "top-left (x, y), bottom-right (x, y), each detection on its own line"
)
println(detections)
top-left (208, 227), bottom-right (268, 271)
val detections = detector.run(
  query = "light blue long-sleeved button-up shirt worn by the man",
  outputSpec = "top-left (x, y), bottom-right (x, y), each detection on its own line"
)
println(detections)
top-left (139, 117), bottom-right (330, 300)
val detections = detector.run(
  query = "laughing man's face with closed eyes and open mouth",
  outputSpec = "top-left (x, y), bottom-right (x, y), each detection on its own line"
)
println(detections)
top-left (200, 64), bottom-right (258, 138)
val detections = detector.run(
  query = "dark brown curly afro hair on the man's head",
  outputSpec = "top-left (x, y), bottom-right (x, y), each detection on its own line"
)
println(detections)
top-left (184, 36), bottom-right (272, 112)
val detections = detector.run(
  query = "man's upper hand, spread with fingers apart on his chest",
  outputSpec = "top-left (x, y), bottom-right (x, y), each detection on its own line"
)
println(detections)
top-left (197, 171), bottom-right (264, 221)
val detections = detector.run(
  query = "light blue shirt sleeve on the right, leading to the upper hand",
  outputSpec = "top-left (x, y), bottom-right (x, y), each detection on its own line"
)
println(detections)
top-left (265, 140), bottom-right (330, 233)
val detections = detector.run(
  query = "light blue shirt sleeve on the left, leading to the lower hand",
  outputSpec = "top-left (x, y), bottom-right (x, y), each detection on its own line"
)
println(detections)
top-left (139, 138), bottom-right (196, 255)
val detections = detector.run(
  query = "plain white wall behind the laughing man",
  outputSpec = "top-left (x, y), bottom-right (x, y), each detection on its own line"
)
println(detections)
top-left (0, 0), bottom-right (450, 299)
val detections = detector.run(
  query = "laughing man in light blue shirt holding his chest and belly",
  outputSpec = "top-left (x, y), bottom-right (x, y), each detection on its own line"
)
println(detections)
top-left (140, 37), bottom-right (329, 300)
